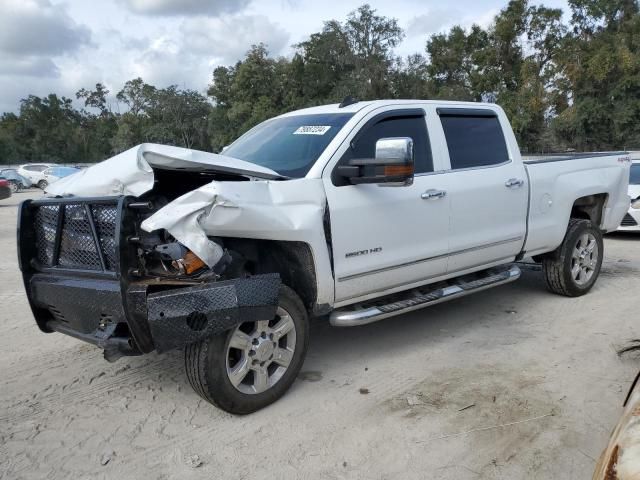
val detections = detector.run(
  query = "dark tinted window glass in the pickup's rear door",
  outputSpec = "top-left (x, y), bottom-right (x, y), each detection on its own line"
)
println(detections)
top-left (440, 114), bottom-right (509, 170)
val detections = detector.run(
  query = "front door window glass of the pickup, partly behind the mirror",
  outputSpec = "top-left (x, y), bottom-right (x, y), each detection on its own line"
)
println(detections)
top-left (340, 116), bottom-right (433, 173)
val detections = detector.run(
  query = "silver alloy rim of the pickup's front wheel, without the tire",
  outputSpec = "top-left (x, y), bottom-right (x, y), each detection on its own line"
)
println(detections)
top-left (227, 307), bottom-right (296, 395)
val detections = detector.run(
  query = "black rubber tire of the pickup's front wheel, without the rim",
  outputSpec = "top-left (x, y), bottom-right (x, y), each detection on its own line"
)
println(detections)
top-left (184, 286), bottom-right (309, 415)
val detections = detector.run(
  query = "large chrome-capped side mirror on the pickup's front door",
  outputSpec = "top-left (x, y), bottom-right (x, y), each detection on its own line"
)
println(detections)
top-left (338, 137), bottom-right (414, 186)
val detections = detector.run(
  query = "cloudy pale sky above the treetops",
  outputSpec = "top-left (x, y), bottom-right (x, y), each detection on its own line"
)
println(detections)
top-left (0, 0), bottom-right (567, 112)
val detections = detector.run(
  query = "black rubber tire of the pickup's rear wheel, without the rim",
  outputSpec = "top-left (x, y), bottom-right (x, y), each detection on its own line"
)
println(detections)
top-left (542, 218), bottom-right (604, 297)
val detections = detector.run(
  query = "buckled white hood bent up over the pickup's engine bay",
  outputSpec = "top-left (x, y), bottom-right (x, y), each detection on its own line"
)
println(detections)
top-left (46, 143), bottom-right (281, 197)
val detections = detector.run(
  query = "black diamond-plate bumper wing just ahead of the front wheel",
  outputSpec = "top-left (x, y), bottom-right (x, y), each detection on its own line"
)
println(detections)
top-left (147, 274), bottom-right (280, 353)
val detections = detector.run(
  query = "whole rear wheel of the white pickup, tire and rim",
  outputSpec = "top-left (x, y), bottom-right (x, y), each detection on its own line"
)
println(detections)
top-left (542, 219), bottom-right (604, 297)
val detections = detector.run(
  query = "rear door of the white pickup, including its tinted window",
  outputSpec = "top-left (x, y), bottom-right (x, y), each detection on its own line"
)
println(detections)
top-left (437, 108), bottom-right (529, 273)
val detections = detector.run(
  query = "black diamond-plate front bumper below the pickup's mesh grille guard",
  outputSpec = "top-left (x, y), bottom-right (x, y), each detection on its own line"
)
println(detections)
top-left (30, 274), bottom-right (280, 361)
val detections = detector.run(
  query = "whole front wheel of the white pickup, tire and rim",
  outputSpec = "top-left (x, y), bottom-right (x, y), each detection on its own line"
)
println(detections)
top-left (185, 286), bottom-right (309, 415)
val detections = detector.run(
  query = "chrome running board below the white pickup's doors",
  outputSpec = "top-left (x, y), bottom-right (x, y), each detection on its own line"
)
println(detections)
top-left (329, 265), bottom-right (521, 327)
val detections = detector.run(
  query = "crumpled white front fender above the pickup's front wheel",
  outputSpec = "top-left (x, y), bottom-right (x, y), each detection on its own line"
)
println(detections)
top-left (141, 178), bottom-right (334, 304)
